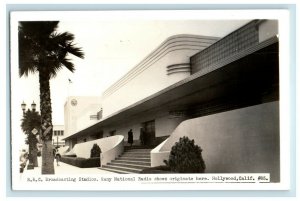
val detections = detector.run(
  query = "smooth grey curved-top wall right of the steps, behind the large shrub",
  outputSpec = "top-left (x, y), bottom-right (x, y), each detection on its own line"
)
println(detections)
top-left (156, 101), bottom-right (280, 182)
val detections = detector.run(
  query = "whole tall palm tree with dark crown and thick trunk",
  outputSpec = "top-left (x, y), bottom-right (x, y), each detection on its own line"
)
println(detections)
top-left (19, 21), bottom-right (84, 174)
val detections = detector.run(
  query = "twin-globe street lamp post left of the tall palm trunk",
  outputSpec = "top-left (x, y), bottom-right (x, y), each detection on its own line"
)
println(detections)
top-left (21, 101), bottom-right (39, 169)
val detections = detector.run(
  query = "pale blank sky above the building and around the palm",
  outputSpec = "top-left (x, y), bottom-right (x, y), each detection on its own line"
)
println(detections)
top-left (11, 13), bottom-right (253, 148)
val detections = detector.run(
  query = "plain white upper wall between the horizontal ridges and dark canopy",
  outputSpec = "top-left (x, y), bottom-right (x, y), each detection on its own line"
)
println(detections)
top-left (103, 50), bottom-right (195, 116)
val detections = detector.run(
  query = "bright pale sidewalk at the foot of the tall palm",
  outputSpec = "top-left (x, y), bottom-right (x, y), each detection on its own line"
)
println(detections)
top-left (21, 157), bottom-right (116, 178)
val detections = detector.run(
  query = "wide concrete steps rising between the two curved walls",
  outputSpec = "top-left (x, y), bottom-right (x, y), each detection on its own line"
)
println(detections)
top-left (99, 147), bottom-right (151, 174)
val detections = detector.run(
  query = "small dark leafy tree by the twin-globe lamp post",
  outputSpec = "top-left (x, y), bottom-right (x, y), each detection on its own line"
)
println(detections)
top-left (21, 109), bottom-right (41, 168)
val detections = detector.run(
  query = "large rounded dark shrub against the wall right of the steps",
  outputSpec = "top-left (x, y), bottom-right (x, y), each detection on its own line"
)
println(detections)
top-left (164, 136), bottom-right (205, 173)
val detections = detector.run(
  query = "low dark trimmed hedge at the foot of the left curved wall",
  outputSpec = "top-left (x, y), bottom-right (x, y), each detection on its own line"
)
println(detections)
top-left (60, 156), bottom-right (101, 168)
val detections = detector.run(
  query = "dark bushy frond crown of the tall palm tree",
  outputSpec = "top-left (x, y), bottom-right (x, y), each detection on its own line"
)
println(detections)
top-left (19, 21), bottom-right (84, 78)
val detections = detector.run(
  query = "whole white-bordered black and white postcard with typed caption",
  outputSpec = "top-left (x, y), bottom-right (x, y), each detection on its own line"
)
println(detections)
top-left (10, 10), bottom-right (290, 190)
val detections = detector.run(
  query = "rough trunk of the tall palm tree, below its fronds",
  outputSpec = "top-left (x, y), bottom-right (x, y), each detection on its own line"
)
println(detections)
top-left (39, 68), bottom-right (54, 174)
